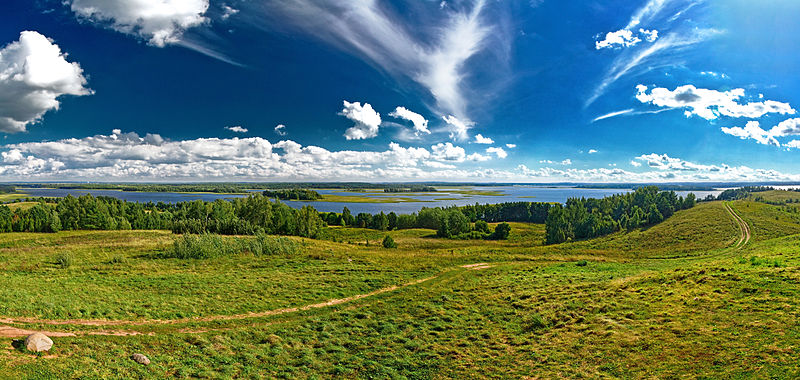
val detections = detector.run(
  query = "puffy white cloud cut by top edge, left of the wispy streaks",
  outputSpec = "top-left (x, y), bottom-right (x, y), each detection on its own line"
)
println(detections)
top-left (71, 0), bottom-right (208, 47)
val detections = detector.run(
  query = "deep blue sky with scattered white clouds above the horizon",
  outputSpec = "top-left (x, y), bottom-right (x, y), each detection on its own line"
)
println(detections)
top-left (0, 0), bottom-right (800, 183)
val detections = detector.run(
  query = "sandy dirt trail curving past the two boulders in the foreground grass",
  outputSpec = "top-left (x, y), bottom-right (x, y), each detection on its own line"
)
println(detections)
top-left (0, 263), bottom-right (456, 338)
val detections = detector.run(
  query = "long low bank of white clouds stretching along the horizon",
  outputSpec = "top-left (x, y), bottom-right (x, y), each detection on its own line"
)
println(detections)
top-left (0, 130), bottom-right (800, 182)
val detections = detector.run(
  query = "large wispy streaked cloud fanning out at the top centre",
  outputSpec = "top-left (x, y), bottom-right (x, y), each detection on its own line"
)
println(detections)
top-left (254, 0), bottom-right (500, 119)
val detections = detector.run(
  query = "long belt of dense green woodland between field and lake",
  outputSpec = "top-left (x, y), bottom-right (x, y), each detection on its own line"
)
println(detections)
top-left (0, 187), bottom-right (695, 244)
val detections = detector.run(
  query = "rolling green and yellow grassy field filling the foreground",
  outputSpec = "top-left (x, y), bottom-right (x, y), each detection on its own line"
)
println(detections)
top-left (0, 201), bottom-right (800, 379)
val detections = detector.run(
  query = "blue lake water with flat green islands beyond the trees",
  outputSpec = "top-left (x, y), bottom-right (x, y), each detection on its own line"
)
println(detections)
top-left (19, 186), bottom-right (721, 214)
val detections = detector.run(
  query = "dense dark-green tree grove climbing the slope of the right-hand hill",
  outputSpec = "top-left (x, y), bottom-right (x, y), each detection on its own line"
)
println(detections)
top-left (545, 186), bottom-right (697, 244)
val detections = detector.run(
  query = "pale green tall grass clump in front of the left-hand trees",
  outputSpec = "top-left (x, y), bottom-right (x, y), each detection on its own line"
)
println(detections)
top-left (164, 234), bottom-right (300, 259)
